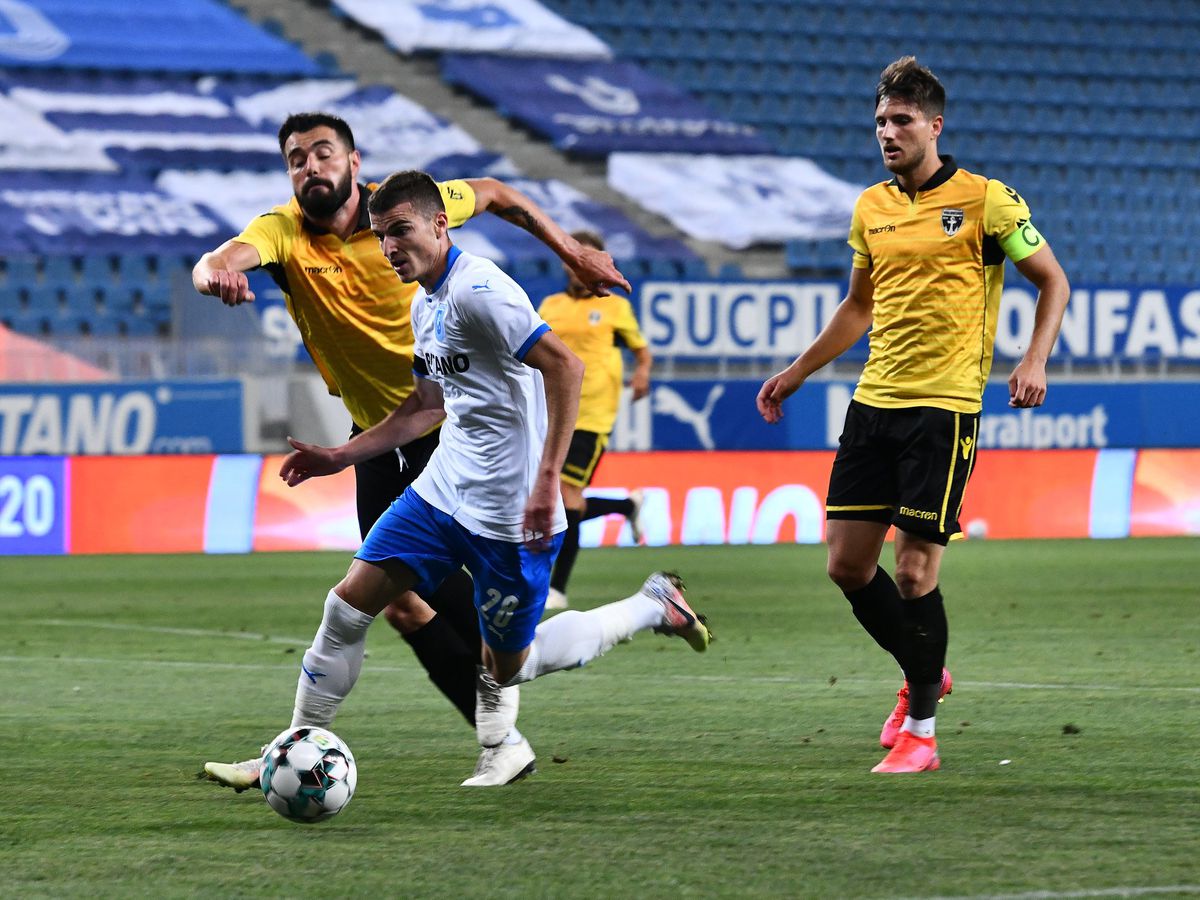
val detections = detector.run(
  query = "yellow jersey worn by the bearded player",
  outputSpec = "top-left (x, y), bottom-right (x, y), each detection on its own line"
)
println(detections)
top-left (234, 181), bottom-right (475, 428)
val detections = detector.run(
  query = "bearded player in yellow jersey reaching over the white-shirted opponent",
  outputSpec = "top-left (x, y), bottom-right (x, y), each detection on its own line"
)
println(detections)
top-left (192, 113), bottom-right (629, 786)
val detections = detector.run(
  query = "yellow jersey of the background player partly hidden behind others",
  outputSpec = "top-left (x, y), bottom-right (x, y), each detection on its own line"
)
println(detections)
top-left (538, 292), bottom-right (646, 434)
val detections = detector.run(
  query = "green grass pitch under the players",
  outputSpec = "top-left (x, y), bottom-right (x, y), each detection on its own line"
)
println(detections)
top-left (0, 540), bottom-right (1200, 898)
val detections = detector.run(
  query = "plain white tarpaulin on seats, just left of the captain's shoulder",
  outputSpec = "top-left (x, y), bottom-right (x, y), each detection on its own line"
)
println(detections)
top-left (608, 154), bottom-right (863, 250)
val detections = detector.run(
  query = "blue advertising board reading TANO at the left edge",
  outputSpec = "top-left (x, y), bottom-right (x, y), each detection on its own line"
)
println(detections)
top-left (0, 380), bottom-right (245, 456)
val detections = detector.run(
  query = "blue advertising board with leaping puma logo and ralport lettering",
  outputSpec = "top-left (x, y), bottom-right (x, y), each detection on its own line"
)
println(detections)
top-left (611, 380), bottom-right (1200, 450)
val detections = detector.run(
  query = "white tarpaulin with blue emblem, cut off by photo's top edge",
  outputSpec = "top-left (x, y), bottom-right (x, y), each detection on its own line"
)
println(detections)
top-left (334, 0), bottom-right (611, 59)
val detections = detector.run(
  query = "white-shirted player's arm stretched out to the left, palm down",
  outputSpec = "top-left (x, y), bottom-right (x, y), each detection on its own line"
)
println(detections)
top-left (280, 378), bottom-right (445, 487)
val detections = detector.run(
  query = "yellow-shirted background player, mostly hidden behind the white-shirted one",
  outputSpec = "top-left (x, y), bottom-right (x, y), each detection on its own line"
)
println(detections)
top-left (538, 232), bottom-right (653, 610)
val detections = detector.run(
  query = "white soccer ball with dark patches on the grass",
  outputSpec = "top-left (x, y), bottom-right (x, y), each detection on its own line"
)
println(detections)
top-left (259, 726), bottom-right (359, 822)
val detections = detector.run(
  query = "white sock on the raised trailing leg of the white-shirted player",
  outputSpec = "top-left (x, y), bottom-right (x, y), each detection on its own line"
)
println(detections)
top-left (506, 593), bottom-right (662, 686)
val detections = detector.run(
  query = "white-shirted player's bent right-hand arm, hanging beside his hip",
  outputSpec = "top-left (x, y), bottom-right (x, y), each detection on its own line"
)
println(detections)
top-left (524, 331), bottom-right (583, 547)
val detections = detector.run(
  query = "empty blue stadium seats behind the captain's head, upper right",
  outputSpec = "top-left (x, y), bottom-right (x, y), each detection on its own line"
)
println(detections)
top-left (546, 0), bottom-right (1200, 284)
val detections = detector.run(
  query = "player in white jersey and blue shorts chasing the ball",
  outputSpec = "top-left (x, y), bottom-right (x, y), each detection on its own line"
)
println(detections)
top-left (202, 172), bottom-right (709, 786)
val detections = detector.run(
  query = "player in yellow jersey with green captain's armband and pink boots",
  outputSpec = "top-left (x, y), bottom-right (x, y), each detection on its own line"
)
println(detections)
top-left (757, 56), bottom-right (1070, 773)
